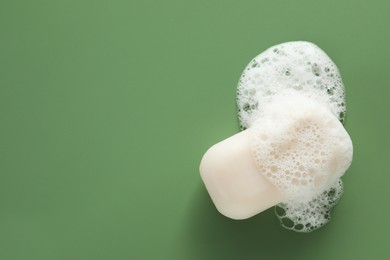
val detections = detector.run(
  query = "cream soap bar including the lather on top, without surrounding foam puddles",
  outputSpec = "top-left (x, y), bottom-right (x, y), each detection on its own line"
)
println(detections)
top-left (200, 91), bottom-right (352, 219)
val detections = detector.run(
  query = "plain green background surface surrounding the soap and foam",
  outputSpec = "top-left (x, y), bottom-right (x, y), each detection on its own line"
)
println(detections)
top-left (0, 0), bottom-right (390, 260)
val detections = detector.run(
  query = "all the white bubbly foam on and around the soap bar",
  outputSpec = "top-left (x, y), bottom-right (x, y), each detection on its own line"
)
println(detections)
top-left (237, 42), bottom-right (353, 232)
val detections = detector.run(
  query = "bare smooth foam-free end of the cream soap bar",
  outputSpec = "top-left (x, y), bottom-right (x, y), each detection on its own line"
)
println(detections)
top-left (200, 130), bottom-right (282, 219)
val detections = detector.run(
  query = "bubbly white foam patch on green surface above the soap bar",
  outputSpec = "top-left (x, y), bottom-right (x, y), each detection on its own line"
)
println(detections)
top-left (237, 42), bottom-right (346, 129)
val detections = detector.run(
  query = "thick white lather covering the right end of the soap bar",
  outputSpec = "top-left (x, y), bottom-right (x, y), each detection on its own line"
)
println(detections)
top-left (251, 93), bottom-right (352, 202)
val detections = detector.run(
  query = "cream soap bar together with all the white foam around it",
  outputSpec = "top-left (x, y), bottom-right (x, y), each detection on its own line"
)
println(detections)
top-left (200, 42), bottom-right (353, 232)
